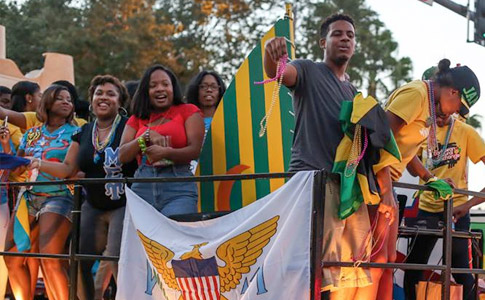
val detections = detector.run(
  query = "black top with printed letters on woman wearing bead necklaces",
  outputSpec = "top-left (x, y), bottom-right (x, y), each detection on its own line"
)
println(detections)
top-left (72, 117), bottom-right (138, 210)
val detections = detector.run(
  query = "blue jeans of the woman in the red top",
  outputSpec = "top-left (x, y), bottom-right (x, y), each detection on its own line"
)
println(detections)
top-left (131, 164), bottom-right (198, 216)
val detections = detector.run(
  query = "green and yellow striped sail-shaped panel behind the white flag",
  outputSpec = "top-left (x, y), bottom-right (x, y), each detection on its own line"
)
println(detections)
top-left (197, 7), bottom-right (295, 212)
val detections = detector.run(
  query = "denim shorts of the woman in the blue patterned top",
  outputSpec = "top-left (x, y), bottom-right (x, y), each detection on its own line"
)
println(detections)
top-left (15, 194), bottom-right (74, 222)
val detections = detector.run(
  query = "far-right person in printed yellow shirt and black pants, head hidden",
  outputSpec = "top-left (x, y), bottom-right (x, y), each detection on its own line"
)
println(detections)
top-left (404, 112), bottom-right (485, 299)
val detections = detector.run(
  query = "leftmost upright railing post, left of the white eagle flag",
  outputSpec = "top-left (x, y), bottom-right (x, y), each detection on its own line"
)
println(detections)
top-left (69, 185), bottom-right (82, 300)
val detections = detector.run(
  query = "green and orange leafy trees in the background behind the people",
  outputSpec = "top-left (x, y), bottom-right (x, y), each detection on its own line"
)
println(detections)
top-left (0, 0), bottom-right (412, 101)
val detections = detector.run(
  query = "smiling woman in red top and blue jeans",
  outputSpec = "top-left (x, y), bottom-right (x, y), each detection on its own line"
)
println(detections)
top-left (120, 65), bottom-right (204, 216)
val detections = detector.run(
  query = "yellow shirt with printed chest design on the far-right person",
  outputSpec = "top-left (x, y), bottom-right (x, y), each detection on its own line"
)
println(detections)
top-left (419, 120), bottom-right (485, 212)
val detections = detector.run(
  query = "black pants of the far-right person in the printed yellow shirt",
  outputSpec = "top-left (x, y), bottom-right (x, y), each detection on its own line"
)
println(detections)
top-left (404, 210), bottom-right (475, 300)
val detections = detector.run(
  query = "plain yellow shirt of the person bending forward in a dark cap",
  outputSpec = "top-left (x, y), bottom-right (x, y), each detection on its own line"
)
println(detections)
top-left (385, 80), bottom-right (430, 181)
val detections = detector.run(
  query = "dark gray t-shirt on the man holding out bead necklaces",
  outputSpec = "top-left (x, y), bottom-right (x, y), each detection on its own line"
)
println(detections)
top-left (289, 59), bottom-right (357, 171)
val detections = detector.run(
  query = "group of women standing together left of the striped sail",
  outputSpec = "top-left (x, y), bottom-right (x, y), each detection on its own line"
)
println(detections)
top-left (0, 65), bottom-right (225, 299)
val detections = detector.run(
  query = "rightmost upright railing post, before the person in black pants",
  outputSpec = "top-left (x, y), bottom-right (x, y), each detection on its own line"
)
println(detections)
top-left (441, 198), bottom-right (453, 299)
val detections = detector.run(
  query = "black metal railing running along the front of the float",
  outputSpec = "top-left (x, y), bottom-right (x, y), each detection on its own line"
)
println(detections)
top-left (0, 170), bottom-right (485, 300)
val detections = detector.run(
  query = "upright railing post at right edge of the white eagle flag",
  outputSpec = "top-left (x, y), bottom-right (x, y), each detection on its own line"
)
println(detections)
top-left (310, 170), bottom-right (327, 300)
